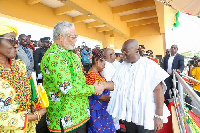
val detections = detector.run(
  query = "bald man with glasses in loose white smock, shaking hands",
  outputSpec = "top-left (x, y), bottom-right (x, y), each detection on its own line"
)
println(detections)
top-left (107, 39), bottom-right (170, 133)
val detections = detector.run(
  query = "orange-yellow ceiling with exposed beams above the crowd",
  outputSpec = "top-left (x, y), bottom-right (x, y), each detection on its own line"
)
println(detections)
top-left (27, 0), bottom-right (162, 36)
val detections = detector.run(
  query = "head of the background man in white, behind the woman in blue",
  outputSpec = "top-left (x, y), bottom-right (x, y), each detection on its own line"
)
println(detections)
top-left (104, 48), bottom-right (116, 63)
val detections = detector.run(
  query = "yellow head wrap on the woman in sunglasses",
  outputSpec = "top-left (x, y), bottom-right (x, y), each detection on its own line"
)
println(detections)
top-left (0, 20), bottom-right (18, 36)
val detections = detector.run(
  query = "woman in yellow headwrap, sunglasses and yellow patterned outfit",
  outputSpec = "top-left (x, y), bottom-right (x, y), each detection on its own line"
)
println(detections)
top-left (0, 20), bottom-right (46, 133)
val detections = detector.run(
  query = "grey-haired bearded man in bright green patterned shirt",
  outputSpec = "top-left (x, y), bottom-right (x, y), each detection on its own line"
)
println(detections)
top-left (40, 21), bottom-right (104, 133)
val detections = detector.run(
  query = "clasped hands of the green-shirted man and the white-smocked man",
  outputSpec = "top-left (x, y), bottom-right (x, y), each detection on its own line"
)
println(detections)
top-left (94, 81), bottom-right (114, 95)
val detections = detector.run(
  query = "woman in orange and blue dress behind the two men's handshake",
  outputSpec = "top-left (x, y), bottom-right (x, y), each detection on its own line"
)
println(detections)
top-left (86, 49), bottom-right (116, 133)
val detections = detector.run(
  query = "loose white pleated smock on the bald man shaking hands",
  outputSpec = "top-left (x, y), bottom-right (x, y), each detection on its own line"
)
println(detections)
top-left (107, 57), bottom-right (170, 130)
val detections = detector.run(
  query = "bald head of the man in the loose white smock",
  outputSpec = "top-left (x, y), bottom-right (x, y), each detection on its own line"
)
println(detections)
top-left (122, 39), bottom-right (140, 63)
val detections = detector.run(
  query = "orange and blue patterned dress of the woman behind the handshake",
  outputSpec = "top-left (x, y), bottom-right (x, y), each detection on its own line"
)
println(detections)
top-left (86, 71), bottom-right (116, 133)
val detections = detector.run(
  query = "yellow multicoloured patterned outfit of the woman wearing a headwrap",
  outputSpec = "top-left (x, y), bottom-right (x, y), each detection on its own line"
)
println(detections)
top-left (0, 60), bottom-right (35, 133)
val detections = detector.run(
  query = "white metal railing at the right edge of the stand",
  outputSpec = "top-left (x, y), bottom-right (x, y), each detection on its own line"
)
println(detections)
top-left (172, 70), bottom-right (200, 133)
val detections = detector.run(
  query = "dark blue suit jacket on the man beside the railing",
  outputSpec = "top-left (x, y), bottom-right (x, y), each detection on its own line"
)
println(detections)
top-left (162, 53), bottom-right (184, 72)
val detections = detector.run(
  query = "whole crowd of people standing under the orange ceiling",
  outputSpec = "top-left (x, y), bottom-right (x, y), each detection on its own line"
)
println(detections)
top-left (0, 20), bottom-right (200, 133)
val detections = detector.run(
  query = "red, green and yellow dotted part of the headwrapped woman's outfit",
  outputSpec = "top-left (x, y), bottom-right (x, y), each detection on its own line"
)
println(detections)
top-left (0, 60), bottom-right (31, 112)
